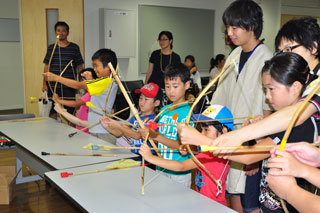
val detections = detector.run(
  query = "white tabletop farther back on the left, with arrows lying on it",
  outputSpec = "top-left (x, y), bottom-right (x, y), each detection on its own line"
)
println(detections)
top-left (0, 118), bottom-right (137, 169)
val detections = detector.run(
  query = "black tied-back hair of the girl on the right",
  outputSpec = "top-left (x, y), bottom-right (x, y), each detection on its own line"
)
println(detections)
top-left (262, 52), bottom-right (317, 94)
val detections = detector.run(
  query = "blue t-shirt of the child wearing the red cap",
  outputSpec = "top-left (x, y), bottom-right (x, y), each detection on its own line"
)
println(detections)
top-left (128, 113), bottom-right (156, 154)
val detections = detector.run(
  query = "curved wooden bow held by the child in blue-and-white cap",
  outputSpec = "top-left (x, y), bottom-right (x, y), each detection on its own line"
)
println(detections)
top-left (186, 54), bottom-right (240, 187)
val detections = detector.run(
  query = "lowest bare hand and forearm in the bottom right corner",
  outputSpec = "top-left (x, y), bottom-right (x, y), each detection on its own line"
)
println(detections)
top-left (267, 171), bottom-right (320, 212)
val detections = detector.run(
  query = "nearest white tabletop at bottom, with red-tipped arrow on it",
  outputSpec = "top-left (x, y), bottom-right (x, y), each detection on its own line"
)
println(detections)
top-left (45, 163), bottom-right (234, 213)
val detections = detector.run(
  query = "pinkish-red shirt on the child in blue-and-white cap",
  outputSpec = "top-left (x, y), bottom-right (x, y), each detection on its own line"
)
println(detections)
top-left (195, 152), bottom-right (230, 206)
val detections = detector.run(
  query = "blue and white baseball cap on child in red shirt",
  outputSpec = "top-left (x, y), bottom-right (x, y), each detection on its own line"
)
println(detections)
top-left (192, 104), bottom-right (233, 130)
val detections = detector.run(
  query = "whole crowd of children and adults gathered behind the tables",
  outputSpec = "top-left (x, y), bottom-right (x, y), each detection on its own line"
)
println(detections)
top-left (43, 0), bottom-right (320, 212)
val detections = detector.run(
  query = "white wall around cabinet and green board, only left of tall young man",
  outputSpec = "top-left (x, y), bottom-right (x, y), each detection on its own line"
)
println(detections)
top-left (84, 0), bottom-right (232, 80)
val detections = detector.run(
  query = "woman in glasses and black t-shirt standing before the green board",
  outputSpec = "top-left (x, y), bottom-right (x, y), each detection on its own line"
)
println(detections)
top-left (145, 31), bottom-right (181, 89)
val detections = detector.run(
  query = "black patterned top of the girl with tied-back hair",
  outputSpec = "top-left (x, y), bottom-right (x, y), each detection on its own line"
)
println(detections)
top-left (259, 118), bottom-right (316, 213)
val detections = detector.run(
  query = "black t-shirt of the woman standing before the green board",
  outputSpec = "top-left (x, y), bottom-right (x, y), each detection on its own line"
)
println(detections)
top-left (148, 50), bottom-right (181, 88)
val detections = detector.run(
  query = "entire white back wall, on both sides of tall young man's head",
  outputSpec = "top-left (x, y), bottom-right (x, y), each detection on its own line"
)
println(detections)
top-left (84, 0), bottom-right (281, 80)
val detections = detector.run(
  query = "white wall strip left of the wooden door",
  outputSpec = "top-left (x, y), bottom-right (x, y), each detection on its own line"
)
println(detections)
top-left (0, 0), bottom-right (24, 110)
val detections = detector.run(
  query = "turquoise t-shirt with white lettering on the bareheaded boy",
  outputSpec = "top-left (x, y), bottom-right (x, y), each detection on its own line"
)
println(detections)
top-left (157, 103), bottom-right (193, 175)
